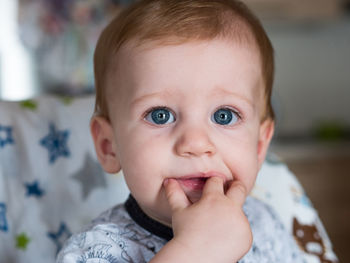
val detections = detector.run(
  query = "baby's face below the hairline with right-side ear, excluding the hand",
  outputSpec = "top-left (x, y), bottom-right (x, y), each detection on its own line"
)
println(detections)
top-left (101, 40), bottom-right (273, 224)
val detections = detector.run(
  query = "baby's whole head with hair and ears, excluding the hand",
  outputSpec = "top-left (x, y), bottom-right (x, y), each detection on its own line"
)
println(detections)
top-left (91, 0), bottom-right (274, 227)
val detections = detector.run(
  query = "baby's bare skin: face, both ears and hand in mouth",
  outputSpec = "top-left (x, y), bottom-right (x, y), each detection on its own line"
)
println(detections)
top-left (91, 39), bottom-right (273, 263)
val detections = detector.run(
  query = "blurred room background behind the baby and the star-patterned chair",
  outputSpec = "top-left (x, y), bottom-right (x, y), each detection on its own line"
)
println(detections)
top-left (0, 0), bottom-right (350, 262)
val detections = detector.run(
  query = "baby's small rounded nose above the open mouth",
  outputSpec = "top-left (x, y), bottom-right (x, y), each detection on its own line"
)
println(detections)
top-left (175, 127), bottom-right (216, 157)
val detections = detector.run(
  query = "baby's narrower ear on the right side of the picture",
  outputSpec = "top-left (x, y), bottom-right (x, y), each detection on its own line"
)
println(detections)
top-left (258, 119), bottom-right (275, 167)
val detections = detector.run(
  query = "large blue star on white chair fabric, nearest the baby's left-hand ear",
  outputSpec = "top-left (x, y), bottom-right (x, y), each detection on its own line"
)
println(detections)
top-left (40, 124), bottom-right (70, 164)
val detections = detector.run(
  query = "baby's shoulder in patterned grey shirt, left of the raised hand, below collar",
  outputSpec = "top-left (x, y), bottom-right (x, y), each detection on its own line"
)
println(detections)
top-left (57, 205), bottom-right (164, 263)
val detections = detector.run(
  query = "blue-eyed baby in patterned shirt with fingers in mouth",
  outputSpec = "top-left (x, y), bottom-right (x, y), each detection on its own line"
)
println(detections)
top-left (58, 0), bottom-right (303, 263)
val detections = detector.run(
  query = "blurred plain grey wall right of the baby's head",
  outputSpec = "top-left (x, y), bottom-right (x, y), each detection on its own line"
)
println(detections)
top-left (266, 17), bottom-right (350, 137)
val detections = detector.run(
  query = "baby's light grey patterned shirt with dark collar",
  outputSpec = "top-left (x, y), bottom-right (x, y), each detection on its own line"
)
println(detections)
top-left (57, 195), bottom-right (304, 263)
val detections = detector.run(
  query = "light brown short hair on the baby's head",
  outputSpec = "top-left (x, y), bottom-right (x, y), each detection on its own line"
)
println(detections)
top-left (94, 0), bottom-right (274, 120)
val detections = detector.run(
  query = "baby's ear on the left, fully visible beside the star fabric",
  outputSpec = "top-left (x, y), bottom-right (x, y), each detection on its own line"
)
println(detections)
top-left (90, 117), bottom-right (121, 173)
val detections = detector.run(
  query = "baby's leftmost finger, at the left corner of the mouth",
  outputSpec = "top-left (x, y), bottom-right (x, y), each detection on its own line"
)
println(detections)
top-left (164, 179), bottom-right (191, 212)
